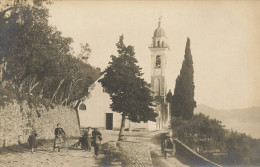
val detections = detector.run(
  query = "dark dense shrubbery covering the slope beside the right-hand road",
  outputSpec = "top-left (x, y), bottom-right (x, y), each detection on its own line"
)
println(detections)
top-left (171, 114), bottom-right (260, 165)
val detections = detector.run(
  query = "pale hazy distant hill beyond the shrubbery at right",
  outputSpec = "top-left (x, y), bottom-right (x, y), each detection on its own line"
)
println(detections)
top-left (194, 104), bottom-right (260, 138)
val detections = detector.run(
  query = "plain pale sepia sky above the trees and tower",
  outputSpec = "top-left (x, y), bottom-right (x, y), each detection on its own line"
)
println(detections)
top-left (49, 0), bottom-right (260, 109)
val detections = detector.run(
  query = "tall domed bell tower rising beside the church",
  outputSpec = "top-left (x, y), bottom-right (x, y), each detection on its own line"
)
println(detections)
top-left (149, 17), bottom-right (169, 129)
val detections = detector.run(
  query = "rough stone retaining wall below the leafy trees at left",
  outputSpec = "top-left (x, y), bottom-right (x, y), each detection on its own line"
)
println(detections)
top-left (0, 101), bottom-right (80, 147)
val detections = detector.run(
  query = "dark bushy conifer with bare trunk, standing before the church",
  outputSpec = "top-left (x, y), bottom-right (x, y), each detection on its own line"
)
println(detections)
top-left (99, 35), bottom-right (157, 140)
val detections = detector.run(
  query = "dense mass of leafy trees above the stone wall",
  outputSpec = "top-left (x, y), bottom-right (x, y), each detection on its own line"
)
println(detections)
top-left (0, 1), bottom-right (100, 106)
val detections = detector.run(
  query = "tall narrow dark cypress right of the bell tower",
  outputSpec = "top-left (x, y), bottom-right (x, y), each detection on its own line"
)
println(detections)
top-left (171, 38), bottom-right (196, 120)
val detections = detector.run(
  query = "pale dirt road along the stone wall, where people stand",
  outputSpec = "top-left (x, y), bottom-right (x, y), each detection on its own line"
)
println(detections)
top-left (0, 131), bottom-right (118, 167)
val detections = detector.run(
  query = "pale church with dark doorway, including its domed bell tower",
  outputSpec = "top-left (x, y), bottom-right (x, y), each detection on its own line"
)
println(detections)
top-left (78, 18), bottom-right (170, 130)
